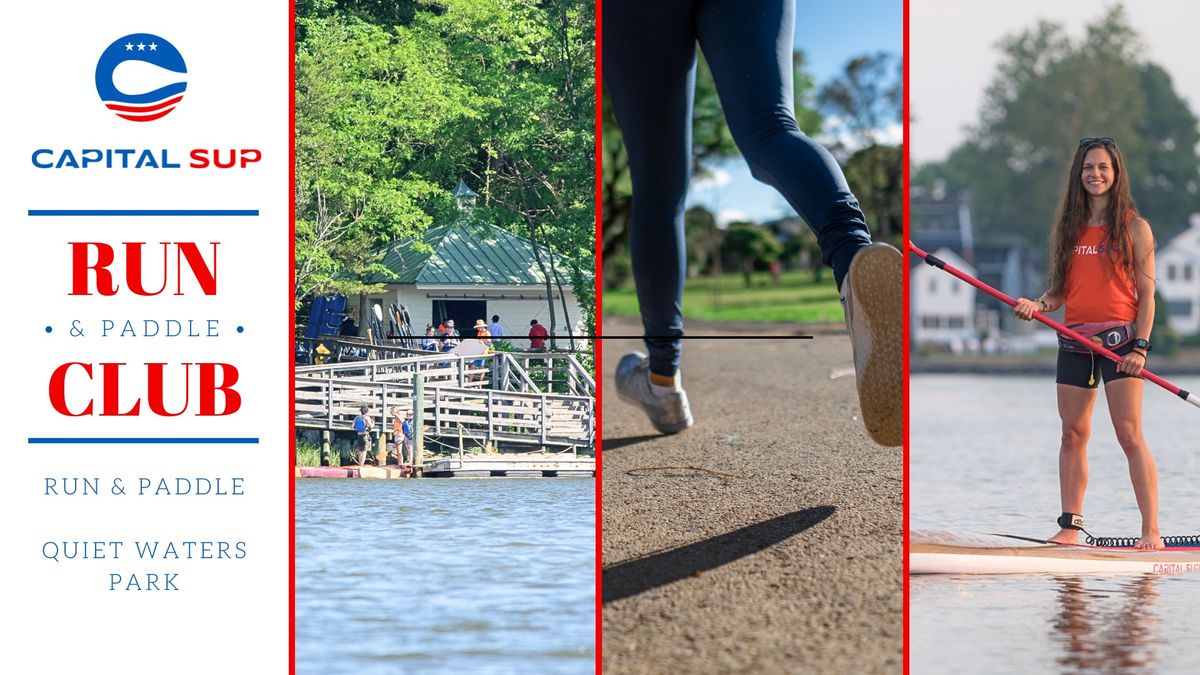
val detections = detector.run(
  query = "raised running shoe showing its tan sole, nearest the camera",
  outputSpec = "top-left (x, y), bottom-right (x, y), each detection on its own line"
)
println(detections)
top-left (841, 244), bottom-right (904, 446)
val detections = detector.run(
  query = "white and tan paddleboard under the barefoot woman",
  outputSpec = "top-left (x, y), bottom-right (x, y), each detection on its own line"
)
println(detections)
top-left (908, 538), bottom-right (1200, 574)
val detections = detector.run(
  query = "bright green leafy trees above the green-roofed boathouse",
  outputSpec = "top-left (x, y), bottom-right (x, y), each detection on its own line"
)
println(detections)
top-left (295, 0), bottom-right (595, 333)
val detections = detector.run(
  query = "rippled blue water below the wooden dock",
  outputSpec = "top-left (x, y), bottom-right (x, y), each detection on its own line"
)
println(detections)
top-left (295, 478), bottom-right (595, 674)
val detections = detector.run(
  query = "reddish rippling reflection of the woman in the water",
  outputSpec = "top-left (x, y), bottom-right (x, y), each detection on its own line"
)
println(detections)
top-left (1051, 574), bottom-right (1163, 673)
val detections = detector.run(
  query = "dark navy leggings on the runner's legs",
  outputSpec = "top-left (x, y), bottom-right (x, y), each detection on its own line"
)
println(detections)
top-left (604, 0), bottom-right (871, 375)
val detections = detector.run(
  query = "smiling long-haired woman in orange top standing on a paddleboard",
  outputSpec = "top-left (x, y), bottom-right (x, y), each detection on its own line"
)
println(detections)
top-left (1013, 138), bottom-right (1163, 549)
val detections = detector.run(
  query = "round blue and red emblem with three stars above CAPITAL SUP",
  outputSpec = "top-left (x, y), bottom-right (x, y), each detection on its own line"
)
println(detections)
top-left (96, 32), bottom-right (187, 121)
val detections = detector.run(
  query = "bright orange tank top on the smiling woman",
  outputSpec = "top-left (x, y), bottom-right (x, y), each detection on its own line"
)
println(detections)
top-left (1063, 226), bottom-right (1138, 323)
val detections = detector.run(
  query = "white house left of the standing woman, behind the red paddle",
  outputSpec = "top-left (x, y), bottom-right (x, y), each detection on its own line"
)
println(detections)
top-left (908, 246), bottom-right (976, 346)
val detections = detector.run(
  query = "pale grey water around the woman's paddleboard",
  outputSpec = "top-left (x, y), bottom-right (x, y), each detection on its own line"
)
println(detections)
top-left (910, 374), bottom-right (1200, 674)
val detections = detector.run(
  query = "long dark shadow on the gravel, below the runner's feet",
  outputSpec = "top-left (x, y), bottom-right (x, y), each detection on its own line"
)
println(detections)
top-left (604, 506), bottom-right (836, 604)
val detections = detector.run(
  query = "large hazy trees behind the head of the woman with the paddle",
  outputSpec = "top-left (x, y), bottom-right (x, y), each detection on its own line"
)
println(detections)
top-left (913, 6), bottom-right (1200, 243)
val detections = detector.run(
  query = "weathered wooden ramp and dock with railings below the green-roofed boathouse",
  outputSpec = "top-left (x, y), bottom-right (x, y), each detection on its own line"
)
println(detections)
top-left (295, 348), bottom-right (595, 461)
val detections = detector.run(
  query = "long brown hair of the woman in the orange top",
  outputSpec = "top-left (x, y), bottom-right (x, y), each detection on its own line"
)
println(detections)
top-left (1048, 139), bottom-right (1139, 295)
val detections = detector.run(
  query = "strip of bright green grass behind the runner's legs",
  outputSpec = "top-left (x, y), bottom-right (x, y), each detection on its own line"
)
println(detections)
top-left (602, 270), bottom-right (845, 323)
